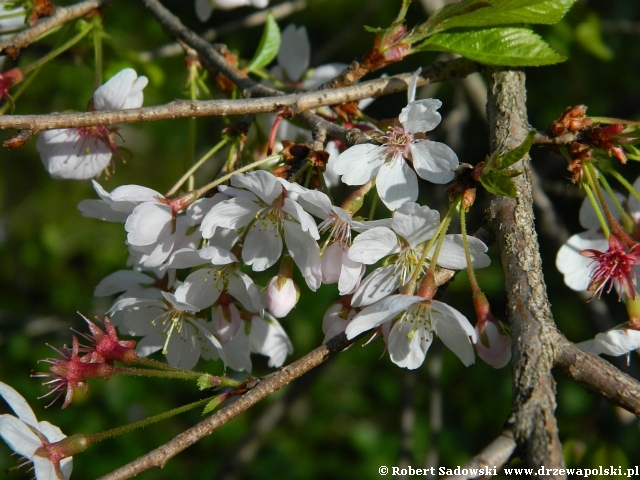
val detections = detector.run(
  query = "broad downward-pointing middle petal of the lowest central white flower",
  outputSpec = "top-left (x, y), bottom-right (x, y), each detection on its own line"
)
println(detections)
top-left (387, 321), bottom-right (433, 370)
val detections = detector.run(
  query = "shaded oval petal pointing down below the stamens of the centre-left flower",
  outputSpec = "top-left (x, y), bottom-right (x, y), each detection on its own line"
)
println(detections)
top-left (242, 218), bottom-right (282, 272)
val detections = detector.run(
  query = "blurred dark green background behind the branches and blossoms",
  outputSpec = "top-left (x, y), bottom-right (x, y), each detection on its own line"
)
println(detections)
top-left (0, 0), bottom-right (640, 480)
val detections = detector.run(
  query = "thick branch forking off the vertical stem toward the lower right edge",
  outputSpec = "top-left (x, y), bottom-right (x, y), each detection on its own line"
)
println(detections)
top-left (554, 334), bottom-right (640, 417)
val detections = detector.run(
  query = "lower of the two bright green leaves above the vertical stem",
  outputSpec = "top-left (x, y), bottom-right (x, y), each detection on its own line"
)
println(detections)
top-left (414, 27), bottom-right (566, 67)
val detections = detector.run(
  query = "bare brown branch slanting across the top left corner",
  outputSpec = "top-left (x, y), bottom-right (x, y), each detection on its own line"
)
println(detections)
top-left (0, 0), bottom-right (113, 56)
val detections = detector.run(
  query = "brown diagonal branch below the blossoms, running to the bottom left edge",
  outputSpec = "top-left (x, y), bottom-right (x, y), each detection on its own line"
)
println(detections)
top-left (95, 333), bottom-right (353, 480)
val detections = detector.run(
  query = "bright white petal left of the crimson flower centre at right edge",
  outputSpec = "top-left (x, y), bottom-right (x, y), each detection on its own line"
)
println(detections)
top-left (556, 230), bottom-right (609, 292)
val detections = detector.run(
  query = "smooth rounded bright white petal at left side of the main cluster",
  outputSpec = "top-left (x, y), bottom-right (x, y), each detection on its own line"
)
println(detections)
top-left (124, 202), bottom-right (173, 248)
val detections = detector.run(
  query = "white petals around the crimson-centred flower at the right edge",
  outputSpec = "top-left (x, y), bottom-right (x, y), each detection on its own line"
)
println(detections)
top-left (556, 177), bottom-right (640, 292)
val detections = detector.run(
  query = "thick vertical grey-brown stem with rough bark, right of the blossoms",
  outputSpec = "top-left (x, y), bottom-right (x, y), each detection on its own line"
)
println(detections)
top-left (487, 67), bottom-right (564, 478)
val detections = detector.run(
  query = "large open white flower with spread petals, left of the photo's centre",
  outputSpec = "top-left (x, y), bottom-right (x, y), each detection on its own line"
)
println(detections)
top-left (200, 170), bottom-right (321, 291)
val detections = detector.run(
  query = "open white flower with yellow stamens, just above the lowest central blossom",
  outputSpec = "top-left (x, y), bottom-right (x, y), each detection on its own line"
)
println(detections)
top-left (349, 202), bottom-right (491, 307)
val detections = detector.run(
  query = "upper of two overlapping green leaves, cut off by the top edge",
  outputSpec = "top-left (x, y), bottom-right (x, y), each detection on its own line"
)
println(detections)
top-left (429, 0), bottom-right (576, 31)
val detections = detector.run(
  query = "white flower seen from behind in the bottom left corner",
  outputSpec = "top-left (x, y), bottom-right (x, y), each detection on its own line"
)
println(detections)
top-left (0, 382), bottom-right (73, 480)
